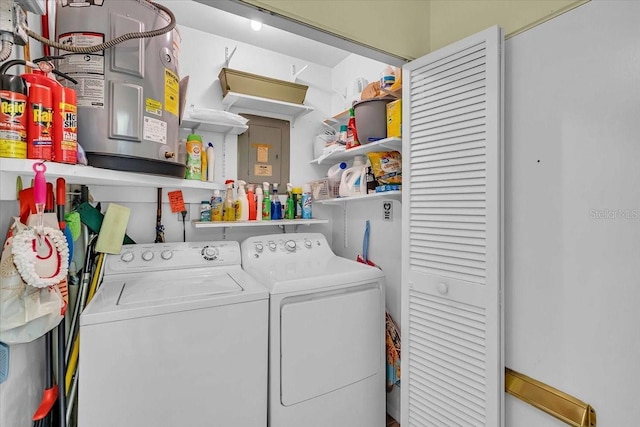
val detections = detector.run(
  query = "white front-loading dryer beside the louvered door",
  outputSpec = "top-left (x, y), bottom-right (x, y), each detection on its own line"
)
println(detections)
top-left (241, 233), bottom-right (386, 427)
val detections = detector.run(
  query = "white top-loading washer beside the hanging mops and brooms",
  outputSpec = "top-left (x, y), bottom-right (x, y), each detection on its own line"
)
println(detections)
top-left (78, 241), bottom-right (269, 427)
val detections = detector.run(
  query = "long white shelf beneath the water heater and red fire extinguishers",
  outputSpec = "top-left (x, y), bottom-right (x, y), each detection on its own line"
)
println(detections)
top-left (0, 158), bottom-right (226, 190)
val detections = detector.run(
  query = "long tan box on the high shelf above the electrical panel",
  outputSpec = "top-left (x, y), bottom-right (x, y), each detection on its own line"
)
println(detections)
top-left (218, 68), bottom-right (309, 104)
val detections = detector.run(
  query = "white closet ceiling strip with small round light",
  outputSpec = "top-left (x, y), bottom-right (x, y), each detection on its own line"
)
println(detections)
top-left (155, 0), bottom-right (351, 68)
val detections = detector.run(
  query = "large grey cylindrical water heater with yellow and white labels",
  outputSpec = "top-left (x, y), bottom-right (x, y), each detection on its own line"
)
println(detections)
top-left (56, 0), bottom-right (185, 178)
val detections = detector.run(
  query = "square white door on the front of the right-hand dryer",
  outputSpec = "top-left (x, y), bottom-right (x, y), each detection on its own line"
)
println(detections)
top-left (280, 282), bottom-right (384, 406)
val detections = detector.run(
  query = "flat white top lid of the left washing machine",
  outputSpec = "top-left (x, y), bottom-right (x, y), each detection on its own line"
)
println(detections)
top-left (116, 273), bottom-right (242, 305)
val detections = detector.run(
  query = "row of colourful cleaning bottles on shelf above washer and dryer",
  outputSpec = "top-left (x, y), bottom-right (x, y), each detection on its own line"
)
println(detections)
top-left (200, 179), bottom-right (311, 221)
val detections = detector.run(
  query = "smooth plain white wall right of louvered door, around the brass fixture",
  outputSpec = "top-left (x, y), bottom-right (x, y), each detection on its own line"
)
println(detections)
top-left (505, 1), bottom-right (640, 427)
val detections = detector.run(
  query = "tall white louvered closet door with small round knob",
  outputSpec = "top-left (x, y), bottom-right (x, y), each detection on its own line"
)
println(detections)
top-left (401, 27), bottom-right (504, 427)
